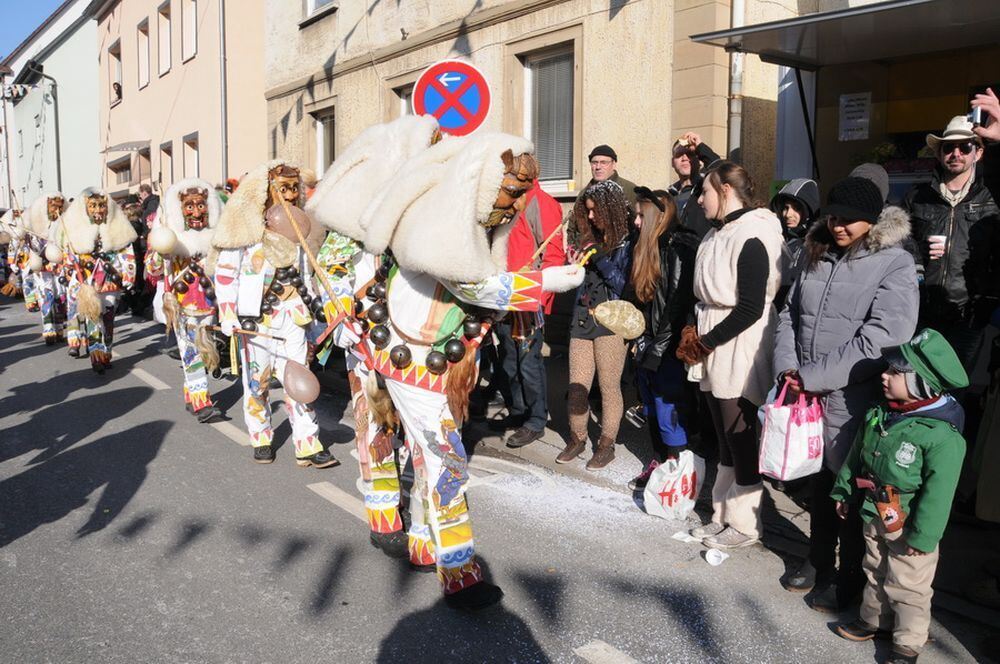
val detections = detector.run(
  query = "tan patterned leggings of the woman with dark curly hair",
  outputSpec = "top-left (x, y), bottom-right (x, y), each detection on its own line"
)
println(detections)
top-left (568, 336), bottom-right (625, 440)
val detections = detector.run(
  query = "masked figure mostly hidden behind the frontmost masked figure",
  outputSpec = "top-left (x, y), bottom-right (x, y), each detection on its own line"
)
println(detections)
top-left (306, 115), bottom-right (441, 560)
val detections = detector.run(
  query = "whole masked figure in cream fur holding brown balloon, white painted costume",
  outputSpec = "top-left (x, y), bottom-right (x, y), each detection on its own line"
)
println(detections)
top-left (210, 161), bottom-right (339, 468)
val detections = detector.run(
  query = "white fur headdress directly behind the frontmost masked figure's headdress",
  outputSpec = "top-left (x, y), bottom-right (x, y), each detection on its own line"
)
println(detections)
top-left (306, 115), bottom-right (438, 242)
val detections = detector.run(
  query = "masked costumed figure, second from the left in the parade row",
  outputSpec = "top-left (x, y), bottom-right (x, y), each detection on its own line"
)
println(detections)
top-left (57, 187), bottom-right (136, 374)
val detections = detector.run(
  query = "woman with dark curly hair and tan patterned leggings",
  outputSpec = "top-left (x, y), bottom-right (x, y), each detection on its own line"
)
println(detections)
top-left (556, 180), bottom-right (633, 470)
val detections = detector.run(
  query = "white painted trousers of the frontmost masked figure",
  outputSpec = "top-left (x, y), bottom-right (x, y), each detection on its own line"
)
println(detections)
top-left (385, 379), bottom-right (483, 594)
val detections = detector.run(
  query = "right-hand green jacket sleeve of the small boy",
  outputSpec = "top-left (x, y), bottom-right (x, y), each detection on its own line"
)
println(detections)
top-left (906, 434), bottom-right (965, 553)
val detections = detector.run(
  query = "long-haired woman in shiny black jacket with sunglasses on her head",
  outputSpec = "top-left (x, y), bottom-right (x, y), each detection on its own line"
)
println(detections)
top-left (628, 187), bottom-right (699, 491)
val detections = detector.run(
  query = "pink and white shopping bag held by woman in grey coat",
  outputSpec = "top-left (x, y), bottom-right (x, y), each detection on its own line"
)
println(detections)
top-left (758, 381), bottom-right (823, 482)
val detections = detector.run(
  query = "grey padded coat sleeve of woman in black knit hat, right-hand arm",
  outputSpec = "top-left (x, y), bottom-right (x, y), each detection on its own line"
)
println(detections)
top-left (799, 253), bottom-right (919, 394)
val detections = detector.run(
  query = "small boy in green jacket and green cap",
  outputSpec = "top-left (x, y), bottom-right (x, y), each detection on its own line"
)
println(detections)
top-left (830, 329), bottom-right (969, 663)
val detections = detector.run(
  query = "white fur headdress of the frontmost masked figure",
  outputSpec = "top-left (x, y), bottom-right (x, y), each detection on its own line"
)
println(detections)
top-left (361, 133), bottom-right (535, 281)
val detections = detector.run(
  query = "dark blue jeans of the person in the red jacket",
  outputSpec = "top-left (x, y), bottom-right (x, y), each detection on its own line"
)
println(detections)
top-left (496, 321), bottom-right (549, 431)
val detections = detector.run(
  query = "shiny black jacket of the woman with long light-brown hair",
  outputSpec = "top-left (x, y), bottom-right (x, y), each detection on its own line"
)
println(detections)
top-left (627, 226), bottom-right (700, 371)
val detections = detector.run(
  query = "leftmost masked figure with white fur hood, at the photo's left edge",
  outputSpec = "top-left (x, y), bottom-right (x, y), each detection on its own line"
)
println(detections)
top-left (22, 192), bottom-right (66, 346)
